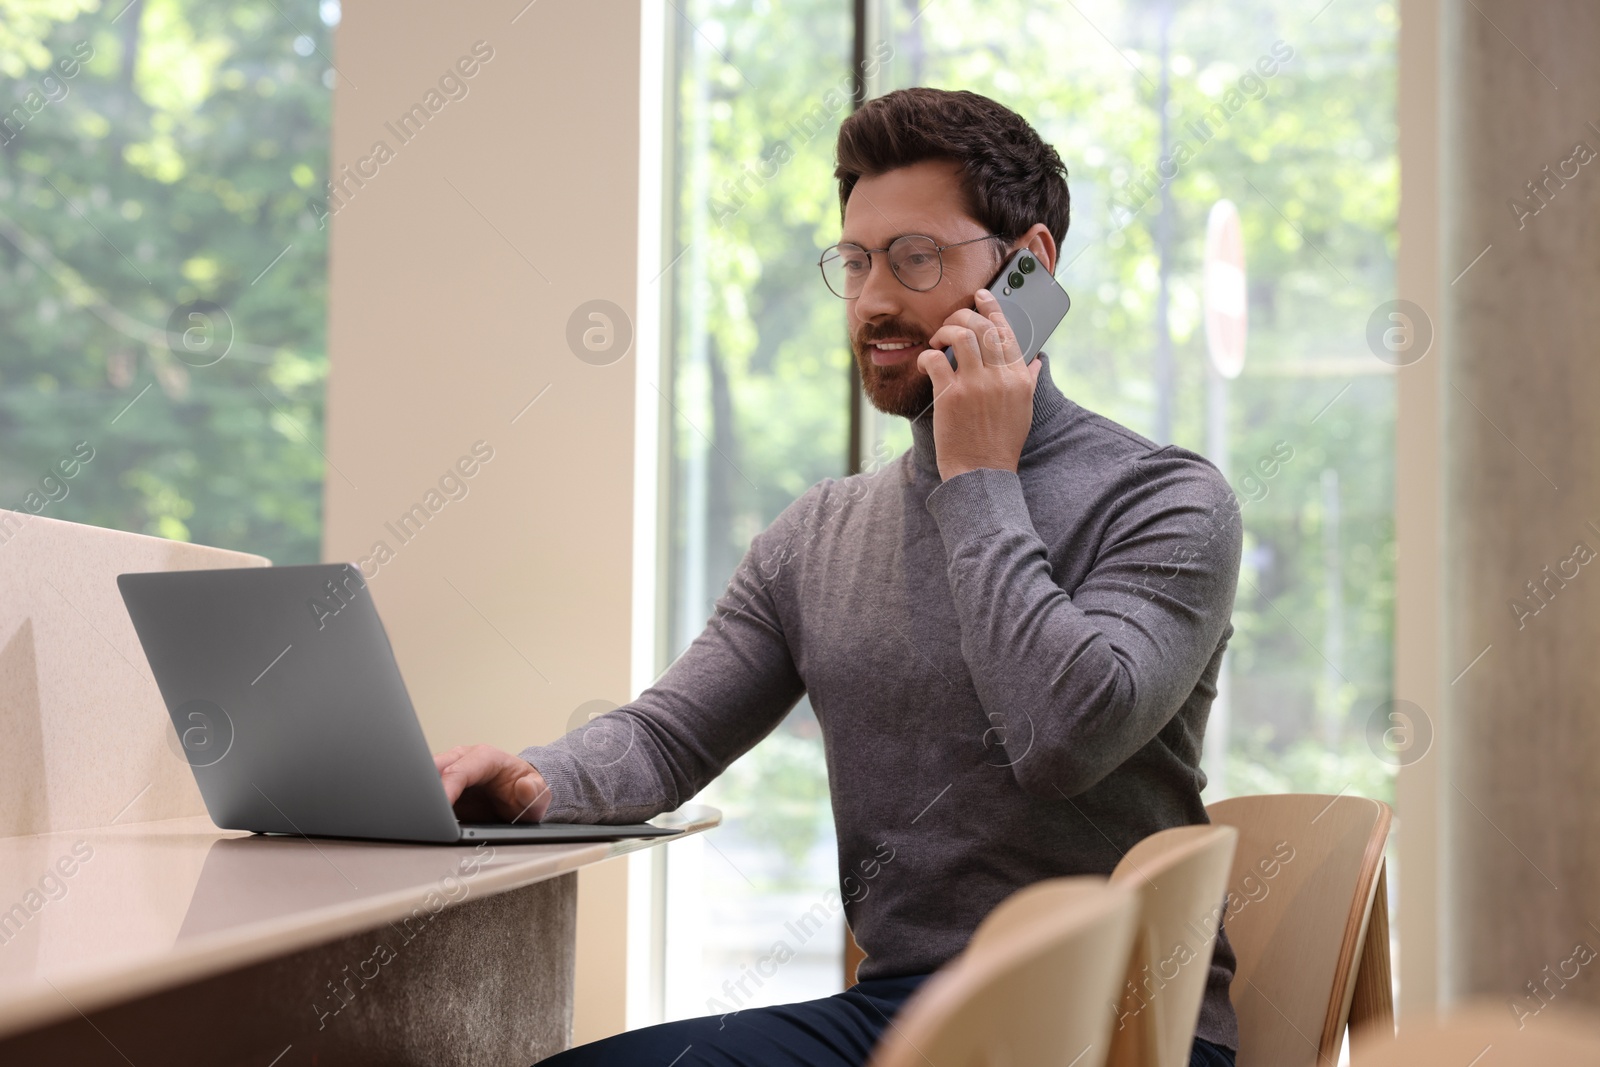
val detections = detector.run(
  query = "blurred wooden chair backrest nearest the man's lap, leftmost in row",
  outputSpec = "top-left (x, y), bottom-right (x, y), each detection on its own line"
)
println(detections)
top-left (869, 877), bottom-right (1139, 1067)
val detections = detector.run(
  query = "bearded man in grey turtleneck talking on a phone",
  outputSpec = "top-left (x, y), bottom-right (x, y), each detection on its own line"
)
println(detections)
top-left (437, 88), bottom-right (1242, 1067)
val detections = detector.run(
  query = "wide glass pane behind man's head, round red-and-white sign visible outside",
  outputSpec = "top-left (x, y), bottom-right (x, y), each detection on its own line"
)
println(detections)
top-left (877, 0), bottom-right (1398, 801)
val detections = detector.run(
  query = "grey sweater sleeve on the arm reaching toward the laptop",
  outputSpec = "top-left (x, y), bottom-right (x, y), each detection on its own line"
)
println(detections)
top-left (518, 483), bottom-right (821, 824)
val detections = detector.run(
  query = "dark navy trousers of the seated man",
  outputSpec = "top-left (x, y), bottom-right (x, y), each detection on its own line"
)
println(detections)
top-left (539, 974), bottom-right (1234, 1067)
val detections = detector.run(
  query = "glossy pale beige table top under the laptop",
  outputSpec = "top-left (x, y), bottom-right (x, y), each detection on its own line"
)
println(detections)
top-left (0, 805), bottom-right (722, 1037)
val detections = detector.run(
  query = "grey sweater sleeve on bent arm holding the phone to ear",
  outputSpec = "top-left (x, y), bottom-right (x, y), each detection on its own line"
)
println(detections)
top-left (926, 448), bottom-right (1243, 798)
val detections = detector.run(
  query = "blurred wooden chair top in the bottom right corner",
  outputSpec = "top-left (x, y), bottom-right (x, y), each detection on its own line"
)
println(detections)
top-left (1350, 1000), bottom-right (1600, 1067)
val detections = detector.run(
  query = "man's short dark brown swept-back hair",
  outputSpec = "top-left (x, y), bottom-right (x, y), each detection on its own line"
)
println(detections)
top-left (834, 86), bottom-right (1072, 248)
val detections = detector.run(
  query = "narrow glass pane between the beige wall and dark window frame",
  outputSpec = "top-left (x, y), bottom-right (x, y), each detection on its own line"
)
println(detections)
top-left (662, 0), bottom-right (851, 1019)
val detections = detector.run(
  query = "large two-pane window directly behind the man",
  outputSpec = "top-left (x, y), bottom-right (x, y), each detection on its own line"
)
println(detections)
top-left (667, 0), bottom-right (1398, 1017)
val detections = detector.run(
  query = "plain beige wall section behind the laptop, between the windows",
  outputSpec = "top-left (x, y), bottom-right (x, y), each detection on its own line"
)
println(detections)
top-left (323, 0), bottom-right (640, 1041)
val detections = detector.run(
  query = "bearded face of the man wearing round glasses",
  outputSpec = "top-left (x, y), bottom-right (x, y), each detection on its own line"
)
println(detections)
top-left (840, 160), bottom-right (1006, 419)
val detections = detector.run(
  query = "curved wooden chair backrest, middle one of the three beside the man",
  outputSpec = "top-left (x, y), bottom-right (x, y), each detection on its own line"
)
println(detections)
top-left (1107, 825), bottom-right (1238, 1067)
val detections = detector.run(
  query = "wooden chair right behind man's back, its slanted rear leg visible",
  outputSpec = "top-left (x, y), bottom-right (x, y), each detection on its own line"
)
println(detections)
top-left (1206, 793), bottom-right (1394, 1067)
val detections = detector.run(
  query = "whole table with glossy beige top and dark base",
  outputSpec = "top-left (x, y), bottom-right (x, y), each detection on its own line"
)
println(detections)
top-left (0, 805), bottom-right (722, 1067)
